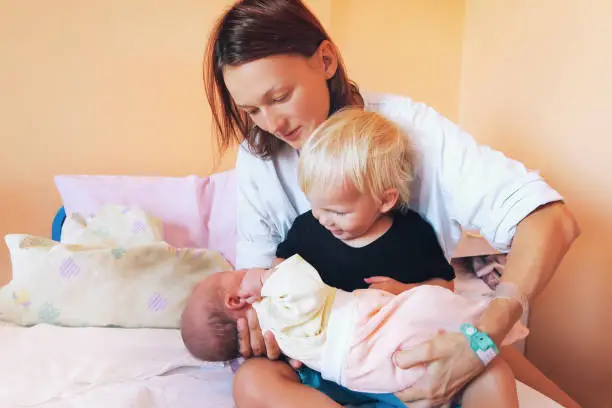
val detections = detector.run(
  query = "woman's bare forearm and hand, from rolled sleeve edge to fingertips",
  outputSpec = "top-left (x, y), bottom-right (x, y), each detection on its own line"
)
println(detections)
top-left (395, 202), bottom-right (580, 406)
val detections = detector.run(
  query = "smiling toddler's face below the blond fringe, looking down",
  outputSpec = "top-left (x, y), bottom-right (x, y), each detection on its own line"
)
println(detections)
top-left (308, 186), bottom-right (381, 241)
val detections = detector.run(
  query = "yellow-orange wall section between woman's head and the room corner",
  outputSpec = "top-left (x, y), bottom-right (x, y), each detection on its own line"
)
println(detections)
top-left (331, 0), bottom-right (465, 120)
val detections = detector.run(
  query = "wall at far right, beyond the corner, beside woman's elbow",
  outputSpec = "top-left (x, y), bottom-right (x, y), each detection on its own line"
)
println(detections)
top-left (460, 0), bottom-right (612, 407)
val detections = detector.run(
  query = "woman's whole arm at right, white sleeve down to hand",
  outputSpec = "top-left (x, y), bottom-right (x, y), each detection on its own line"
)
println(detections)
top-left (384, 95), bottom-right (579, 402)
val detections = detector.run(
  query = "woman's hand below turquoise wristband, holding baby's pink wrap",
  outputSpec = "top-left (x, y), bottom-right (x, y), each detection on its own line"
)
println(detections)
top-left (394, 332), bottom-right (484, 406)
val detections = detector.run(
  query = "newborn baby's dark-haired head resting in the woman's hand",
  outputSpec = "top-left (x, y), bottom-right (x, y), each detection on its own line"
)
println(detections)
top-left (181, 271), bottom-right (250, 361)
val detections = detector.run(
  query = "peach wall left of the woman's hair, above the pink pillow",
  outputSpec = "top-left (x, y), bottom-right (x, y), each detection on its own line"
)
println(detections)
top-left (0, 0), bottom-right (244, 281)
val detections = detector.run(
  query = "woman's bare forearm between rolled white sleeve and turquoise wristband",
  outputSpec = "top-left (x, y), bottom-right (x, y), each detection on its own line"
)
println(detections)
top-left (478, 203), bottom-right (580, 344)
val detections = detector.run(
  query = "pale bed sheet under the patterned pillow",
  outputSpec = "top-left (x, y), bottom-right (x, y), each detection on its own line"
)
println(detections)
top-left (0, 323), bottom-right (559, 408)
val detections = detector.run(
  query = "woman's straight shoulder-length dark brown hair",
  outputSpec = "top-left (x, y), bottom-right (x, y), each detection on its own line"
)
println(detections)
top-left (204, 0), bottom-right (363, 158)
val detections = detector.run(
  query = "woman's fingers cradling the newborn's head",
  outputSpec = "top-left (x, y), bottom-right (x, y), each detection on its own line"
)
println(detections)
top-left (237, 308), bottom-right (302, 369)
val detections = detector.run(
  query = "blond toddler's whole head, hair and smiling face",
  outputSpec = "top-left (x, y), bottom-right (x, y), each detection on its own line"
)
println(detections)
top-left (298, 108), bottom-right (414, 240)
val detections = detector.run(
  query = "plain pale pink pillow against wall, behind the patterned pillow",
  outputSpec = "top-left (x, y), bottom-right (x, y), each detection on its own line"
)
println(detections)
top-left (55, 170), bottom-right (237, 265)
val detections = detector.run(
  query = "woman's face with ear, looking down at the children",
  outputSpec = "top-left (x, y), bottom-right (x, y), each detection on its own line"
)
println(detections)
top-left (223, 41), bottom-right (338, 149)
